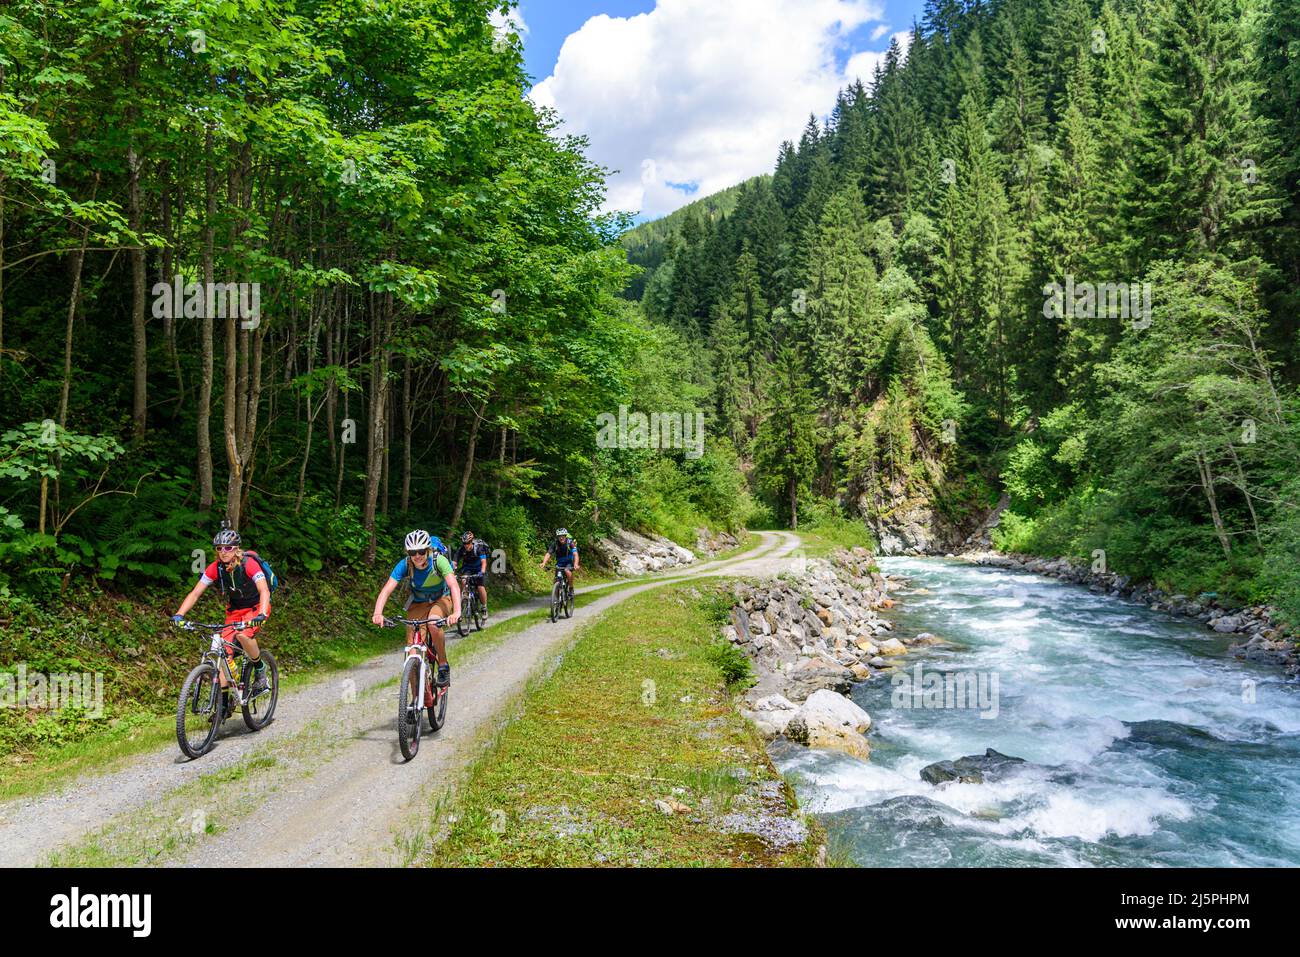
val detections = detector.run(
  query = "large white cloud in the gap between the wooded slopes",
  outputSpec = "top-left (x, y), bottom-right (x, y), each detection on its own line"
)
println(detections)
top-left (530, 0), bottom-right (889, 216)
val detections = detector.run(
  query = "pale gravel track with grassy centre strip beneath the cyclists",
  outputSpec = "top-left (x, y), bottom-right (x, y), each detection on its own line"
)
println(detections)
top-left (0, 532), bottom-right (798, 866)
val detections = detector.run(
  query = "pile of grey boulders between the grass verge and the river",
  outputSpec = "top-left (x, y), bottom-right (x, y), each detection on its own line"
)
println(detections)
top-left (723, 549), bottom-right (915, 759)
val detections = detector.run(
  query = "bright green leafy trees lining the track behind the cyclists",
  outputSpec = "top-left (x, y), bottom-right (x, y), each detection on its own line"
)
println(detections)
top-left (0, 0), bottom-right (746, 598)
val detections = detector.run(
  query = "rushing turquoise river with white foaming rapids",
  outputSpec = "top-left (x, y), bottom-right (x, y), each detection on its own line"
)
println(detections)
top-left (774, 558), bottom-right (1300, 867)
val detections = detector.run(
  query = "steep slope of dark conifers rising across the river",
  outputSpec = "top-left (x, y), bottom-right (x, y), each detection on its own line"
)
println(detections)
top-left (629, 0), bottom-right (1300, 618)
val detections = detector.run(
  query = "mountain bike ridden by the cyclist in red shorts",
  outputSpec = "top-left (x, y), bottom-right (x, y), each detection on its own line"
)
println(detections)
top-left (176, 622), bottom-right (280, 758)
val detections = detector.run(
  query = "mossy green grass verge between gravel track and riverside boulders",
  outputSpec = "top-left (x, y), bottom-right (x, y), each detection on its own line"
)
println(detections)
top-left (417, 583), bottom-right (822, 866)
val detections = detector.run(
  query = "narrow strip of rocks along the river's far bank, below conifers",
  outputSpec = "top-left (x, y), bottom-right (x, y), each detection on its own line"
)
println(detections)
top-left (962, 551), bottom-right (1300, 677)
